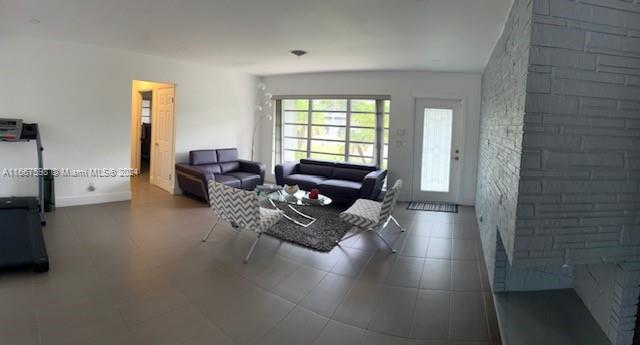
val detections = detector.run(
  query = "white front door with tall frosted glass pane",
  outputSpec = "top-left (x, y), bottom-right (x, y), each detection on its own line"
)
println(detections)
top-left (412, 98), bottom-right (463, 203)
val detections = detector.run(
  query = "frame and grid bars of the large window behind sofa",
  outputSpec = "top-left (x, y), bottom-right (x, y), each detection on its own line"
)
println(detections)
top-left (274, 95), bottom-right (391, 167)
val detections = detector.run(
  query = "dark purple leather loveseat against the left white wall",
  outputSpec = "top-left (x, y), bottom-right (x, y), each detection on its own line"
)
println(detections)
top-left (176, 149), bottom-right (265, 200)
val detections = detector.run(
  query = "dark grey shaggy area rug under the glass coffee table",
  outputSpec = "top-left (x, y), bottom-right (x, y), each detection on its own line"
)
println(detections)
top-left (265, 203), bottom-right (351, 252)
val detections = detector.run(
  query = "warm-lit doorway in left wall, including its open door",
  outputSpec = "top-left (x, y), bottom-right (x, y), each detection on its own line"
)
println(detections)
top-left (131, 80), bottom-right (175, 194)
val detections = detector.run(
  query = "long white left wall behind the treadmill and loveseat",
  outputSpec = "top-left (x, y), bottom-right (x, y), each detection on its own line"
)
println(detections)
top-left (0, 37), bottom-right (256, 206)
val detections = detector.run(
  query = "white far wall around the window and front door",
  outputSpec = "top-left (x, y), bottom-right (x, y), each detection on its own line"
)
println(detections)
top-left (259, 71), bottom-right (481, 205)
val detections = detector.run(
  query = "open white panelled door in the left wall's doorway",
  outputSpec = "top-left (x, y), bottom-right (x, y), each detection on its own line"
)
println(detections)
top-left (149, 87), bottom-right (174, 193)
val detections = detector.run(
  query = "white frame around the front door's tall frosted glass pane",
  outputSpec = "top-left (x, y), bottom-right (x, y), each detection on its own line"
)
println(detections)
top-left (409, 95), bottom-right (468, 204)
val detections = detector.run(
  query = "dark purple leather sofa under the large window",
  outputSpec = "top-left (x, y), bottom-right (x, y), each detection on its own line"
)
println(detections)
top-left (275, 159), bottom-right (387, 204)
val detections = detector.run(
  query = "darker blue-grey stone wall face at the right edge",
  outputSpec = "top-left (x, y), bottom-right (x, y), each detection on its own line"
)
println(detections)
top-left (513, 0), bottom-right (640, 266)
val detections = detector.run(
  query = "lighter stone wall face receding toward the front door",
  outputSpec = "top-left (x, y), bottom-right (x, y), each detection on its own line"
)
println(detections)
top-left (476, 0), bottom-right (532, 282)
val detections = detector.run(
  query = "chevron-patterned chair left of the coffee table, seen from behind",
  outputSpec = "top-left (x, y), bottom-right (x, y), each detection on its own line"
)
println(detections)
top-left (202, 180), bottom-right (283, 263)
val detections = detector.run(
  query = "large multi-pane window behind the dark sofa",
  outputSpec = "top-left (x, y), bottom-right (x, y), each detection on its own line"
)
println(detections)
top-left (278, 98), bottom-right (391, 168)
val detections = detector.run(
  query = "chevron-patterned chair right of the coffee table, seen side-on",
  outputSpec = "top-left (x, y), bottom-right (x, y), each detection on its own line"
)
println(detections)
top-left (338, 180), bottom-right (404, 253)
